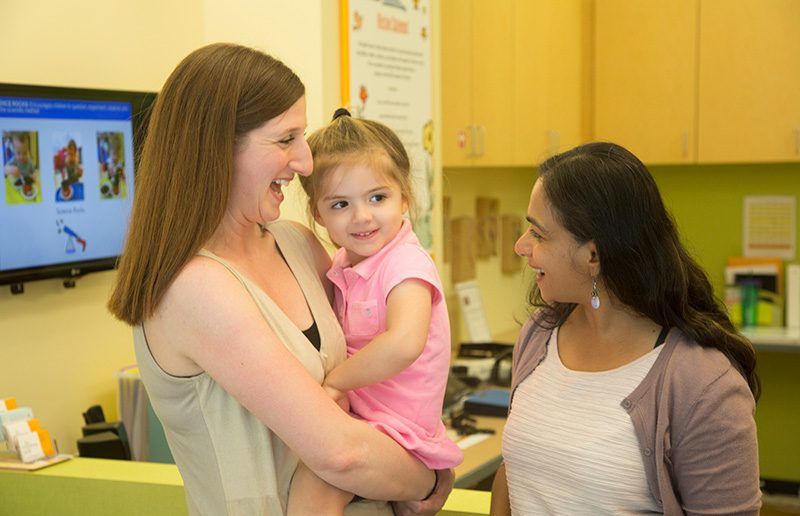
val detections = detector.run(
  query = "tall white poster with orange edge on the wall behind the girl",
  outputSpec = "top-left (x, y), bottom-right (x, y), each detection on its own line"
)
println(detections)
top-left (340, 0), bottom-right (433, 250)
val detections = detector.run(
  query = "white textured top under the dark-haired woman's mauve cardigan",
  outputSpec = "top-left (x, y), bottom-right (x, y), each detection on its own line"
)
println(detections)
top-left (503, 329), bottom-right (663, 515)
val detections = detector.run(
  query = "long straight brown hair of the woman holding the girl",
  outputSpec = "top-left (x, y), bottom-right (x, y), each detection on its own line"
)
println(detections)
top-left (108, 43), bottom-right (305, 325)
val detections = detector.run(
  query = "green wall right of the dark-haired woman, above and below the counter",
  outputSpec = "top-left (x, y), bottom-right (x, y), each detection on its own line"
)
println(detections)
top-left (650, 163), bottom-right (800, 481)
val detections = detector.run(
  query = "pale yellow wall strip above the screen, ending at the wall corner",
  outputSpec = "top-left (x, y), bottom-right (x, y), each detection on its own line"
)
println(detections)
top-left (0, 0), bottom-right (203, 90)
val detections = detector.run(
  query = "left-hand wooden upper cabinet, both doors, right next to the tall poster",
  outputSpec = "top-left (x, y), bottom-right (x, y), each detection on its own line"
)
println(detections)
top-left (441, 0), bottom-right (586, 167)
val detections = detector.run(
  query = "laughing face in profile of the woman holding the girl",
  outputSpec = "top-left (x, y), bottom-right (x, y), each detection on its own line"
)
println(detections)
top-left (228, 97), bottom-right (312, 224)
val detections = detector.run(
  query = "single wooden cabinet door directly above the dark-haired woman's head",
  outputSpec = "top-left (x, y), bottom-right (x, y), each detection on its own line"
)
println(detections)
top-left (593, 0), bottom-right (697, 163)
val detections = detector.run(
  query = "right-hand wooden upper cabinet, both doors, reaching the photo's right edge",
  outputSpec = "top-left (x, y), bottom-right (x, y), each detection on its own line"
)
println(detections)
top-left (591, 0), bottom-right (800, 164)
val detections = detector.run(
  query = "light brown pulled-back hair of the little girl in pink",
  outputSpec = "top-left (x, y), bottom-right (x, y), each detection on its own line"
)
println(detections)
top-left (300, 115), bottom-right (414, 220)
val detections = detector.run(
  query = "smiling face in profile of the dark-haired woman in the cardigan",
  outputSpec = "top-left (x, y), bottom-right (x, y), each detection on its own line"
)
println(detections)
top-left (514, 180), bottom-right (597, 303)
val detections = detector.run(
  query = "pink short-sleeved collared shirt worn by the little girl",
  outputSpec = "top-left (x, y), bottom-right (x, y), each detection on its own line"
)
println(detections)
top-left (328, 220), bottom-right (463, 469)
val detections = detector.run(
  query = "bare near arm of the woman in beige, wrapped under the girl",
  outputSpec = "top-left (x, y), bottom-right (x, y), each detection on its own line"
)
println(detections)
top-left (147, 259), bottom-right (434, 500)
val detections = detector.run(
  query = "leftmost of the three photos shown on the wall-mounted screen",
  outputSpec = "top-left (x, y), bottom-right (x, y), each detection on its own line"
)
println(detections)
top-left (2, 131), bottom-right (42, 204)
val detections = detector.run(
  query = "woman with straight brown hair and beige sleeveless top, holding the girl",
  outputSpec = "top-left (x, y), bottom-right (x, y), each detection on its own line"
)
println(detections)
top-left (109, 44), bottom-right (452, 515)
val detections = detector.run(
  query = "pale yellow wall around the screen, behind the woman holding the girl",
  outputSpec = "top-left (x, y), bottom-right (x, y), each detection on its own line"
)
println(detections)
top-left (0, 0), bottom-right (338, 453)
